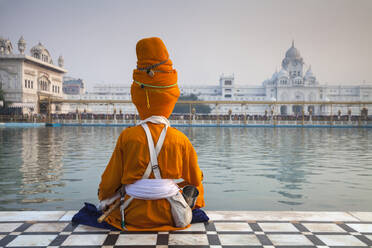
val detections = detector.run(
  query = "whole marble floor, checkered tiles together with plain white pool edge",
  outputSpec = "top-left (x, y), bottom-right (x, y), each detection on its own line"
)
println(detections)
top-left (0, 211), bottom-right (372, 248)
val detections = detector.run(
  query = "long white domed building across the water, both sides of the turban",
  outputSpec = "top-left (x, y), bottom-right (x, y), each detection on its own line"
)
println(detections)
top-left (68, 42), bottom-right (372, 115)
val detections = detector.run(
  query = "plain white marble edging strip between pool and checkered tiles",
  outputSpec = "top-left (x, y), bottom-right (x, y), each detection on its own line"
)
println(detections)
top-left (0, 210), bottom-right (372, 222)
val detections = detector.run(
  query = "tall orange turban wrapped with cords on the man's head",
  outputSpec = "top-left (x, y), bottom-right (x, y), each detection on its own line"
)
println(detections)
top-left (131, 37), bottom-right (180, 120)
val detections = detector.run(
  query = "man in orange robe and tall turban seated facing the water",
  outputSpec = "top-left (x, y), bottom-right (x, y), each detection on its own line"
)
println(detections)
top-left (98, 38), bottom-right (205, 231)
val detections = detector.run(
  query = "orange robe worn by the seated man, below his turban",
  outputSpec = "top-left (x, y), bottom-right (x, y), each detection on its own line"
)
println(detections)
top-left (98, 123), bottom-right (205, 231)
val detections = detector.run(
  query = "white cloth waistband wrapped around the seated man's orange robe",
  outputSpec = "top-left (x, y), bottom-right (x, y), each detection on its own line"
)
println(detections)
top-left (125, 179), bottom-right (179, 200)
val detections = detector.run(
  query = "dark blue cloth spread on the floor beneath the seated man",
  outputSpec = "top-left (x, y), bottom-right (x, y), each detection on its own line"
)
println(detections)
top-left (72, 202), bottom-right (209, 231)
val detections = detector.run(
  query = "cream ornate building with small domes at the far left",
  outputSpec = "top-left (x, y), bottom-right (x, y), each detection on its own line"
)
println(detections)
top-left (0, 37), bottom-right (67, 114)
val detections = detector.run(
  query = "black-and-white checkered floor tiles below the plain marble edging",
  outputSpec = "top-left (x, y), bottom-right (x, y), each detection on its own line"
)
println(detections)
top-left (0, 220), bottom-right (372, 248)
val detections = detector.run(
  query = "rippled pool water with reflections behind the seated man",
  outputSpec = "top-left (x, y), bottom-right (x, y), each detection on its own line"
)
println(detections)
top-left (0, 127), bottom-right (372, 211)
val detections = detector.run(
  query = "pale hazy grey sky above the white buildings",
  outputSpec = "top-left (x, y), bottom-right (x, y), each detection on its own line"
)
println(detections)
top-left (0, 0), bottom-right (372, 86)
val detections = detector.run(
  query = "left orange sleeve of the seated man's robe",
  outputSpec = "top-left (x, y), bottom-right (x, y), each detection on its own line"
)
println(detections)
top-left (98, 133), bottom-right (124, 201)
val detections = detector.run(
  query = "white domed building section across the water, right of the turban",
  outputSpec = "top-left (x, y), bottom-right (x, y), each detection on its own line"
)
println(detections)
top-left (181, 42), bottom-right (372, 115)
